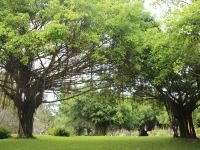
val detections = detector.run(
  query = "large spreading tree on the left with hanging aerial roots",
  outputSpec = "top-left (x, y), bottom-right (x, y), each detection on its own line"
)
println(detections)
top-left (0, 0), bottom-right (148, 137)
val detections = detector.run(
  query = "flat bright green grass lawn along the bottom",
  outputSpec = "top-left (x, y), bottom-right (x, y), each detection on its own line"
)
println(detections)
top-left (0, 136), bottom-right (200, 150)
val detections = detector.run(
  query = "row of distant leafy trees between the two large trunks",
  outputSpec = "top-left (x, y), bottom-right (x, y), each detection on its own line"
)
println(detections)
top-left (58, 91), bottom-right (169, 136)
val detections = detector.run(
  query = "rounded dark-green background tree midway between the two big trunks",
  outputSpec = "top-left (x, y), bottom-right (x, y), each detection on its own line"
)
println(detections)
top-left (66, 93), bottom-right (117, 135)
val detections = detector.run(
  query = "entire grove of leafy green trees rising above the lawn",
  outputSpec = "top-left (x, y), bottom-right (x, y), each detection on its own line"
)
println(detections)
top-left (0, 0), bottom-right (200, 138)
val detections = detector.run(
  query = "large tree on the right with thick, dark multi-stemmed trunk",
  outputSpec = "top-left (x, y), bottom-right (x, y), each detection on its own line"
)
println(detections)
top-left (143, 2), bottom-right (200, 138)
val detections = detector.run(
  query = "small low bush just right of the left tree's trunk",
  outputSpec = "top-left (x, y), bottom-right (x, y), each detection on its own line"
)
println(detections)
top-left (48, 128), bottom-right (70, 137)
